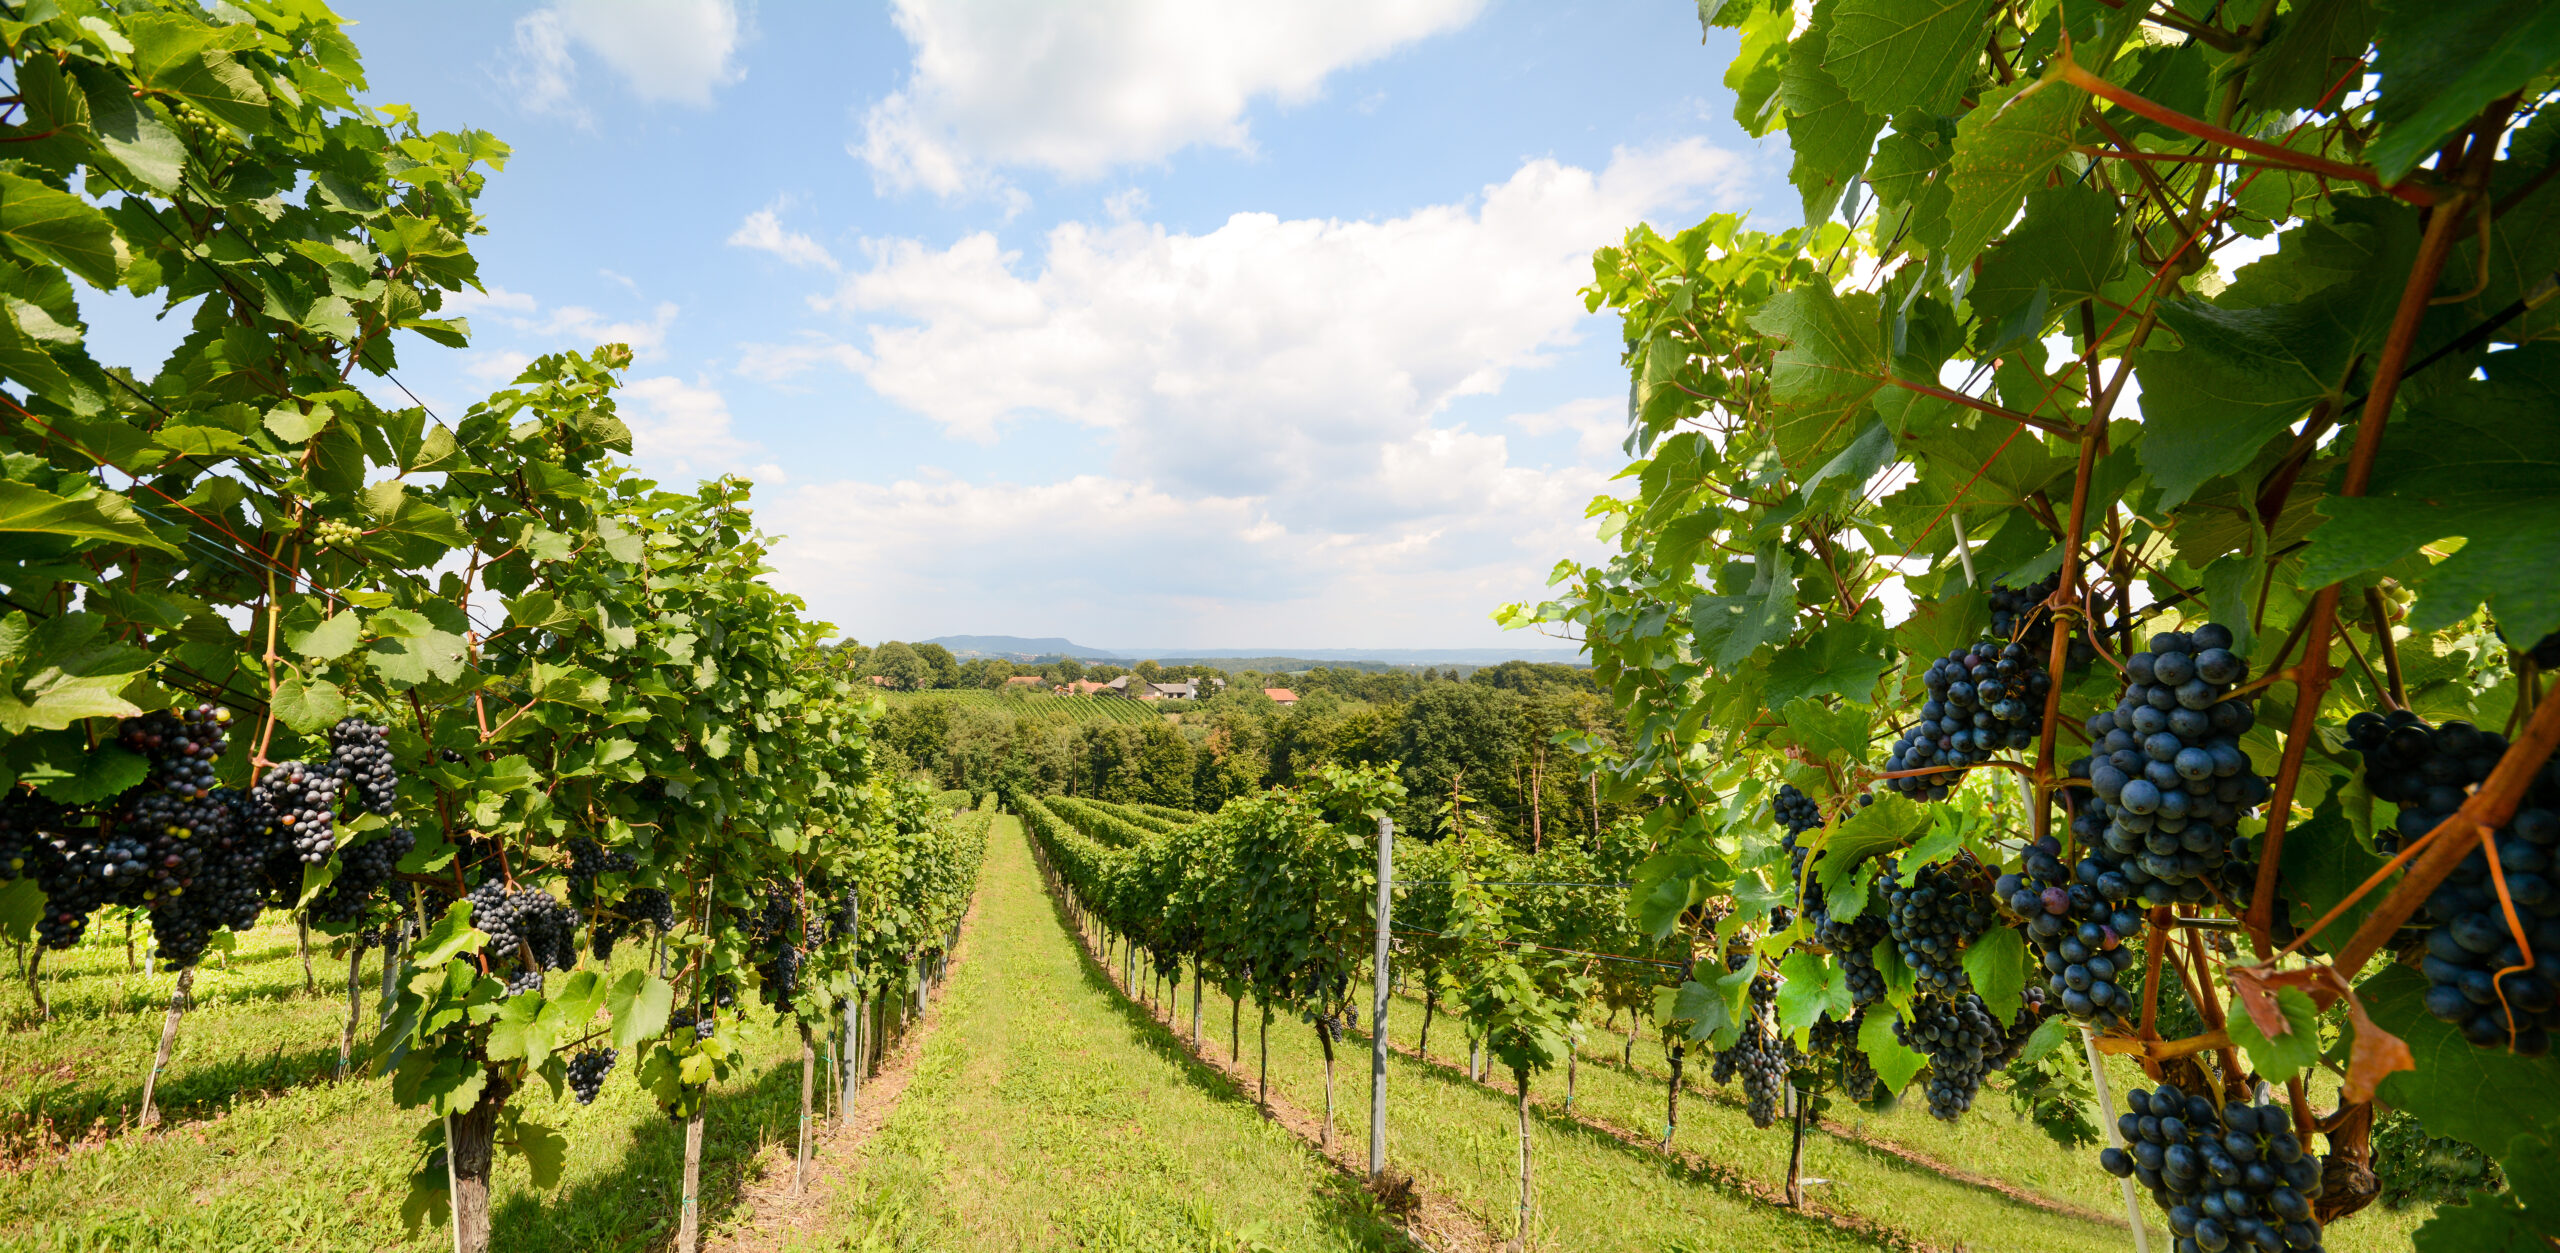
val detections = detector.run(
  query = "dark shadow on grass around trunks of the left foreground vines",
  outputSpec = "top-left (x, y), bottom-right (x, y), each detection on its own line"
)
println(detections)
top-left (489, 1058), bottom-right (799, 1253)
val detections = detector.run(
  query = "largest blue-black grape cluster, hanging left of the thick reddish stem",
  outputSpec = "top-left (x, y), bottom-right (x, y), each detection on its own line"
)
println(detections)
top-left (2071, 625), bottom-right (2273, 905)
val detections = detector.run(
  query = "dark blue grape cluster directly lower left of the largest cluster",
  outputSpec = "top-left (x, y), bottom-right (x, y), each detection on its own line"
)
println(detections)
top-left (1992, 835), bottom-right (2143, 1022)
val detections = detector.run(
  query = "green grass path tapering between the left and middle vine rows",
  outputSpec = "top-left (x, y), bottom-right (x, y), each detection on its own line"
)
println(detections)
top-left (791, 817), bottom-right (1400, 1250)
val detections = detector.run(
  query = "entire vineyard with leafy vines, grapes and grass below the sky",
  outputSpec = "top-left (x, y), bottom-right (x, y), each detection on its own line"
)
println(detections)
top-left (0, 0), bottom-right (2560, 1253)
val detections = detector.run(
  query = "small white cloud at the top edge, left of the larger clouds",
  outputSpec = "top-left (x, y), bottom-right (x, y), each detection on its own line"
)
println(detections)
top-left (502, 0), bottom-right (745, 120)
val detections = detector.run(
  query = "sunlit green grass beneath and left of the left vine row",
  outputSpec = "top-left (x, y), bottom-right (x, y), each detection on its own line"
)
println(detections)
top-left (0, 915), bottom-right (844, 1253)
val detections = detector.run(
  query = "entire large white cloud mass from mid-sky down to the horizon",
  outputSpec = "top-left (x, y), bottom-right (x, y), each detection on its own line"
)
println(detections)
top-left (740, 141), bottom-right (1746, 648)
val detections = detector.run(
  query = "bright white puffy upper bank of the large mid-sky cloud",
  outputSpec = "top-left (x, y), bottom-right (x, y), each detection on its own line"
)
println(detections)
top-left (829, 141), bottom-right (1743, 523)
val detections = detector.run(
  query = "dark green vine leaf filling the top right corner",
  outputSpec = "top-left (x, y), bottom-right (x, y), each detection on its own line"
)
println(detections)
top-left (2350, 0), bottom-right (2560, 184)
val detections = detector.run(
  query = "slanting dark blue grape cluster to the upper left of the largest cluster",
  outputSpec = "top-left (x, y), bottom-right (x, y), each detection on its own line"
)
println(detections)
top-left (1884, 641), bottom-right (2053, 799)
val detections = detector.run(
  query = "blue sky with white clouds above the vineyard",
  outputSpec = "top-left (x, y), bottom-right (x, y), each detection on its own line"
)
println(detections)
top-left (110, 0), bottom-right (1800, 648)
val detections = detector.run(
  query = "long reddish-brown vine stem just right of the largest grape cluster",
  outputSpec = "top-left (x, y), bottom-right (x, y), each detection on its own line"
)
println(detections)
top-left (2245, 183), bottom-right (2486, 958)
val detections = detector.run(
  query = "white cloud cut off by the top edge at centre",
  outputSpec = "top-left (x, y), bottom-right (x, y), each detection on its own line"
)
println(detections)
top-left (852, 0), bottom-right (1482, 195)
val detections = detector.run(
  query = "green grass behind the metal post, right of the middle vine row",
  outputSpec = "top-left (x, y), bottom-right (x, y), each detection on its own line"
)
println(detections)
top-left (1185, 989), bottom-right (2427, 1253)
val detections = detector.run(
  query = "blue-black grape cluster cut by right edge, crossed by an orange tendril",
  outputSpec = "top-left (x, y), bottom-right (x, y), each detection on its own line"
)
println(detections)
top-left (2419, 789), bottom-right (2560, 1056)
